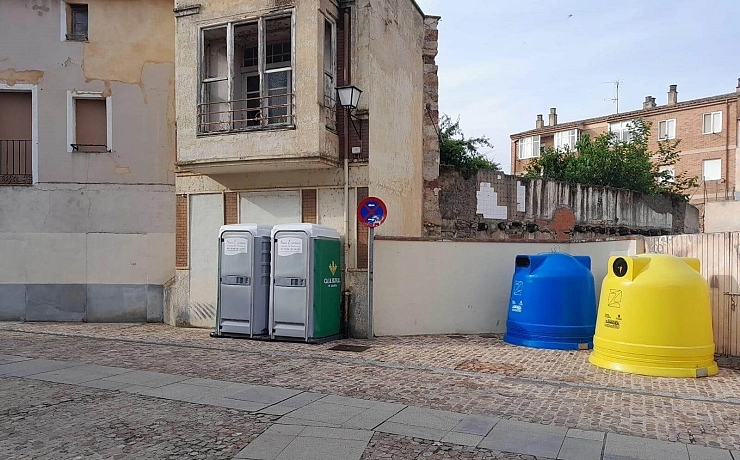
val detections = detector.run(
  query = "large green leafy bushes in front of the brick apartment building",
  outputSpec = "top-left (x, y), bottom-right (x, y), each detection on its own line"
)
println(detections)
top-left (525, 119), bottom-right (698, 198)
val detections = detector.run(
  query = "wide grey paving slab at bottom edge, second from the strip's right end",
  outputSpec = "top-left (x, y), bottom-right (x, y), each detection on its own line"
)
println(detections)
top-left (604, 433), bottom-right (689, 460)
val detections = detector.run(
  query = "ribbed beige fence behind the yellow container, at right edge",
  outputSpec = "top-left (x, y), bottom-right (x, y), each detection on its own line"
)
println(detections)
top-left (645, 232), bottom-right (740, 356)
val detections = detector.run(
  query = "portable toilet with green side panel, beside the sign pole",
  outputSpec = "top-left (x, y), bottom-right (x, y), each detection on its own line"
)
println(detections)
top-left (270, 224), bottom-right (342, 342)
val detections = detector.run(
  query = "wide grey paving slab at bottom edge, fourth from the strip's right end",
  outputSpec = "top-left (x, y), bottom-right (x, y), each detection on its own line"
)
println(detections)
top-left (479, 420), bottom-right (567, 458)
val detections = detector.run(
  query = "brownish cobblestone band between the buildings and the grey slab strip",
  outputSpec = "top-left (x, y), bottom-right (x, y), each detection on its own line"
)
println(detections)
top-left (0, 323), bottom-right (740, 452)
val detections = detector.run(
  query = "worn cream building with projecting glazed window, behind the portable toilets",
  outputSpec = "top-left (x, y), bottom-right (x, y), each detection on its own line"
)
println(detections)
top-left (171, 0), bottom-right (439, 335)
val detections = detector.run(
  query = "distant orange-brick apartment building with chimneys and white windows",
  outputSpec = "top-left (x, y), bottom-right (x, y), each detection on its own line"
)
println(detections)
top-left (511, 81), bottom-right (740, 205)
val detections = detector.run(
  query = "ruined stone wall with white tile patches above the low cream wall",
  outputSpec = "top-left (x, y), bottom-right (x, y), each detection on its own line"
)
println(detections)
top-left (439, 168), bottom-right (699, 242)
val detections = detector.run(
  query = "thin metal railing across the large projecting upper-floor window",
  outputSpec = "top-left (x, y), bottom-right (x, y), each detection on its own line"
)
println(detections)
top-left (198, 93), bottom-right (295, 134)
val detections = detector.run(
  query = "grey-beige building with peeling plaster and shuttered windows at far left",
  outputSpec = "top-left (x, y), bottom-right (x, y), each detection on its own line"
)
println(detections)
top-left (0, 0), bottom-right (175, 321)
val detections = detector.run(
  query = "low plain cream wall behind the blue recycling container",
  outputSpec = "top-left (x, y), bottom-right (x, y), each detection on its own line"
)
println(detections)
top-left (373, 240), bottom-right (643, 336)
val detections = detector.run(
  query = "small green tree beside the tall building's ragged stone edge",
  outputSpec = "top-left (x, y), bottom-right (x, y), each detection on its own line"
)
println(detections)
top-left (439, 115), bottom-right (501, 171)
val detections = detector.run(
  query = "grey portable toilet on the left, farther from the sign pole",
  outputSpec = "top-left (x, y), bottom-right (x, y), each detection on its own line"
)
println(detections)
top-left (216, 224), bottom-right (272, 337)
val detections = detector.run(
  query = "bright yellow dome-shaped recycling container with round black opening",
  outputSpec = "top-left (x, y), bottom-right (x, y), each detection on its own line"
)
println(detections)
top-left (588, 254), bottom-right (718, 377)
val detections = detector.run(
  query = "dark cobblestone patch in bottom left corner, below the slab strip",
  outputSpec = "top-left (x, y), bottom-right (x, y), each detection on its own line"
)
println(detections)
top-left (0, 377), bottom-right (278, 460)
